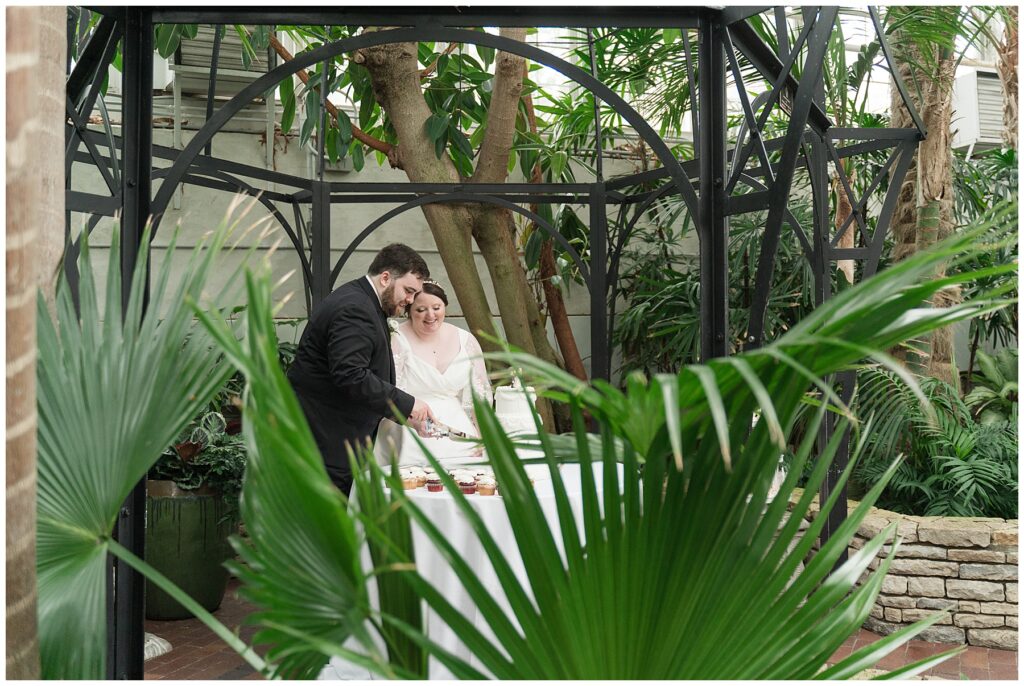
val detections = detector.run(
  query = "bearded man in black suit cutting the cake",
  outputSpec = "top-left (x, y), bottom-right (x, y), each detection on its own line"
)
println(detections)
top-left (288, 243), bottom-right (433, 496)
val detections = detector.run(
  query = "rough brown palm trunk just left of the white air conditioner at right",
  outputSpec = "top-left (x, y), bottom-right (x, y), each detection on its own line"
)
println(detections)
top-left (918, 51), bottom-right (961, 387)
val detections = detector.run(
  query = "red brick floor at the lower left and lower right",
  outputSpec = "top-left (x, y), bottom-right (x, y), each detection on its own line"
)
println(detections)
top-left (145, 580), bottom-right (1017, 681)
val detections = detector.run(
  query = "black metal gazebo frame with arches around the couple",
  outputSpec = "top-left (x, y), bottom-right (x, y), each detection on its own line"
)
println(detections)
top-left (65, 6), bottom-right (926, 679)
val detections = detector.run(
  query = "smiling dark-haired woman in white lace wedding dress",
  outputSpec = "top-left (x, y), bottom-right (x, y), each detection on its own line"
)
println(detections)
top-left (375, 281), bottom-right (490, 466)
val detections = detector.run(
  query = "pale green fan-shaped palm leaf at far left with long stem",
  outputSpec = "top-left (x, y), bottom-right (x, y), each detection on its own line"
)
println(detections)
top-left (37, 209), bottom-right (270, 679)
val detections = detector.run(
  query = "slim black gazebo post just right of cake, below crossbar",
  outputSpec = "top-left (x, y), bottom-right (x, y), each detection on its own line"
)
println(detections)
top-left (590, 183), bottom-right (611, 381)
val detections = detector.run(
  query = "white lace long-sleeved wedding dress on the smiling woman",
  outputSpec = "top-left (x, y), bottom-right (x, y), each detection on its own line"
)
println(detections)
top-left (375, 328), bottom-right (490, 466)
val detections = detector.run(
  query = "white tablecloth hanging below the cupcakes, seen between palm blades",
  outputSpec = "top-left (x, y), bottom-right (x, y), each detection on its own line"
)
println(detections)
top-left (319, 463), bottom-right (622, 679)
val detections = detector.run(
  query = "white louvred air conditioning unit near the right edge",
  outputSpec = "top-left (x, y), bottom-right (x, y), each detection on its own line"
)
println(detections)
top-left (952, 69), bottom-right (1002, 155)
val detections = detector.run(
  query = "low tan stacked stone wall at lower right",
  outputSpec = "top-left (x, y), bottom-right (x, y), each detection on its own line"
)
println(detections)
top-left (790, 495), bottom-right (1018, 650)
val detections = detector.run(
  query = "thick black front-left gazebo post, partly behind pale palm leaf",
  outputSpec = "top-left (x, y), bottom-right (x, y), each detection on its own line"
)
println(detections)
top-left (108, 8), bottom-right (153, 679)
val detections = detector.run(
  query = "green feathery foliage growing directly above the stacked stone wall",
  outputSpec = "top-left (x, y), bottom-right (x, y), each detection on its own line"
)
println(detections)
top-left (855, 370), bottom-right (1018, 519)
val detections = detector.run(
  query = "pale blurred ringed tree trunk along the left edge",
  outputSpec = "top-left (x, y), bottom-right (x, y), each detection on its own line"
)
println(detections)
top-left (6, 6), bottom-right (67, 679)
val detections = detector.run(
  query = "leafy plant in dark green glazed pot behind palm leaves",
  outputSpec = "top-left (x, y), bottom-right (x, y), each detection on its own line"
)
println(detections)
top-left (145, 409), bottom-right (246, 619)
